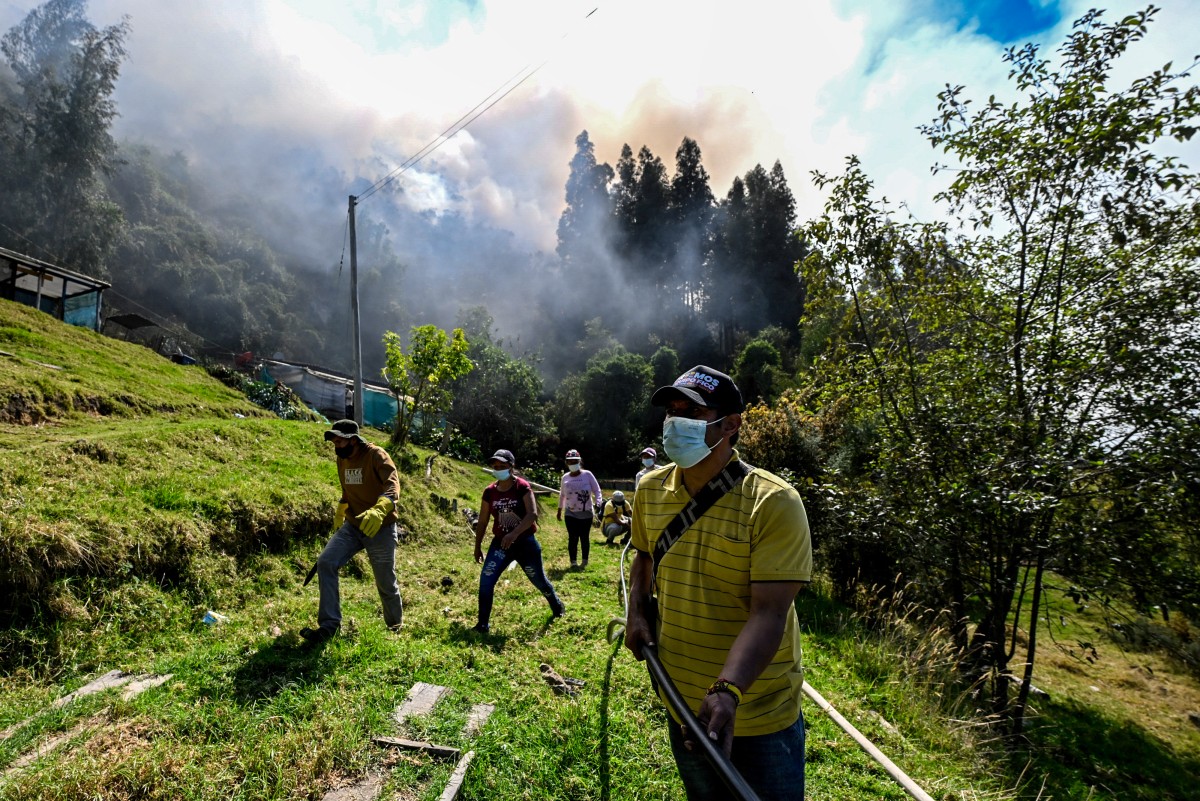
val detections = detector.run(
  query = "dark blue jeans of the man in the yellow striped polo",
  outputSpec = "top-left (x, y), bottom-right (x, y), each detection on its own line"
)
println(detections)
top-left (667, 715), bottom-right (804, 801)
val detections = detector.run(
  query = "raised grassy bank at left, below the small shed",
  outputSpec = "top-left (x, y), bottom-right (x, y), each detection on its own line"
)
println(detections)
top-left (0, 301), bottom-right (332, 647)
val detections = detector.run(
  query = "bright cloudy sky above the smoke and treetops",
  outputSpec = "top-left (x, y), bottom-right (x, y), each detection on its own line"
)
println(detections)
top-left (0, 0), bottom-right (1200, 251)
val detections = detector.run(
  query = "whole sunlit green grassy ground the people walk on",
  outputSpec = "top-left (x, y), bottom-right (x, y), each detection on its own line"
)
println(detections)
top-left (0, 301), bottom-right (1200, 801)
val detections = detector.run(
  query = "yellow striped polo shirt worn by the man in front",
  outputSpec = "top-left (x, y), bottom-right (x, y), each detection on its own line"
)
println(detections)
top-left (632, 452), bottom-right (812, 736)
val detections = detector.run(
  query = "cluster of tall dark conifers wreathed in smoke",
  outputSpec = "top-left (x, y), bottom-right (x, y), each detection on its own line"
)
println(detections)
top-left (558, 131), bottom-right (804, 378)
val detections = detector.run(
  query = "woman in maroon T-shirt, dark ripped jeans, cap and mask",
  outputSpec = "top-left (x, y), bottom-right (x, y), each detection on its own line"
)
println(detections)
top-left (472, 448), bottom-right (564, 634)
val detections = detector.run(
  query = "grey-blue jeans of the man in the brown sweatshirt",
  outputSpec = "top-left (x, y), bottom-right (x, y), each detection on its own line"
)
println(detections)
top-left (317, 522), bottom-right (404, 631)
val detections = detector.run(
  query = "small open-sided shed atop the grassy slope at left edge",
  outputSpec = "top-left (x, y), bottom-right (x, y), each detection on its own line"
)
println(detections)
top-left (0, 247), bottom-right (112, 331)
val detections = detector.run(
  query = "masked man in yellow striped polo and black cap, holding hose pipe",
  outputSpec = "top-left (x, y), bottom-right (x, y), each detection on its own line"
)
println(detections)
top-left (625, 365), bottom-right (812, 801)
